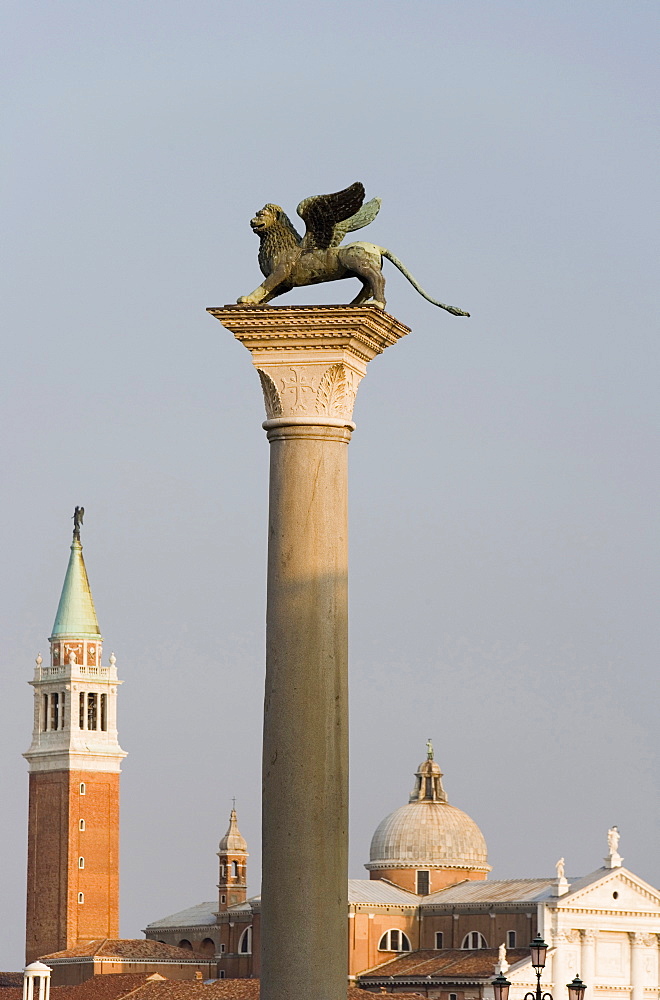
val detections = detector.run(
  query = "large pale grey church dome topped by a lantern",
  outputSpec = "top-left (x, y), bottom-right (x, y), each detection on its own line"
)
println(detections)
top-left (366, 741), bottom-right (490, 878)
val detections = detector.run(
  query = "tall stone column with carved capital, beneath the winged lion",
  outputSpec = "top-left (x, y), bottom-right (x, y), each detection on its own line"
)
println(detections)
top-left (209, 306), bottom-right (409, 1000)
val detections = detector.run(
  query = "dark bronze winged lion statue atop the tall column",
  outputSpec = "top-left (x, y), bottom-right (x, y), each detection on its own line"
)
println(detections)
top-left (238, 181), bottom-right (470, 316)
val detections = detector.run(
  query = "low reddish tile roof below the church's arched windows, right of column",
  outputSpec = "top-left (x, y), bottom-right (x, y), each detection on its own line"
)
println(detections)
top-left (358, 948), bottom-right (529, 982)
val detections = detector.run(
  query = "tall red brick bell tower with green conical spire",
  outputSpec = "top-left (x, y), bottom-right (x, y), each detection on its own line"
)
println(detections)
top-left (23, 507), bottom-right (126, 964)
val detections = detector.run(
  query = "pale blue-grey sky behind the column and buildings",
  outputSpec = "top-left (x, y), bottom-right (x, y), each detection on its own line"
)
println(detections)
top-left (0, 0), bottom-right (660, 970)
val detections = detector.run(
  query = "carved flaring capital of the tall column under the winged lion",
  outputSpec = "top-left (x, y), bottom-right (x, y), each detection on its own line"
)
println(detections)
top-left (207, 305), bottom-right (410, 425)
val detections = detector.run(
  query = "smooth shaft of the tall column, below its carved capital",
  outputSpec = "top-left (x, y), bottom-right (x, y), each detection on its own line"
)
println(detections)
top-left (261, 420), bottom-right (350, 1000)
